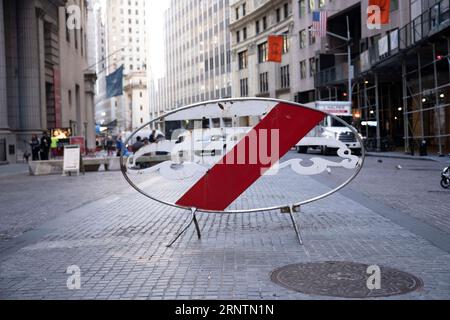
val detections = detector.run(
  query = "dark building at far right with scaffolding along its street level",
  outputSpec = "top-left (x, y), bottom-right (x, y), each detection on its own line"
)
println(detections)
top-left (315, 0), bottom-right (450, 155)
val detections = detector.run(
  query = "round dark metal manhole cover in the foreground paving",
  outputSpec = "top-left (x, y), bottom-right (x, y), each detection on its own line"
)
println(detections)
top-left (271, 262), bottom-right (423, 299)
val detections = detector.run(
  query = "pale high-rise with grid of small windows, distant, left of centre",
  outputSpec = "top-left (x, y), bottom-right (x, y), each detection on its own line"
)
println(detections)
top-left (97, 0), bottom-right (150, 134)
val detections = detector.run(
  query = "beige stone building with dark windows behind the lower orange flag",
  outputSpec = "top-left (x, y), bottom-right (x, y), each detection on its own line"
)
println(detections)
top-left (230, 0), bottom-right (295, 100)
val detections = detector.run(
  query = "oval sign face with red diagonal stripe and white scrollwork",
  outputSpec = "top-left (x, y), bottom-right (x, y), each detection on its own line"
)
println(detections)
top-left (121, 98), bottom-right (364, 213)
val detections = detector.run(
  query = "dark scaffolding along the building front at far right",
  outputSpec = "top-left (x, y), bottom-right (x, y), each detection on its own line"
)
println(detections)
top-left (316, 0), bottom-right (450, 155)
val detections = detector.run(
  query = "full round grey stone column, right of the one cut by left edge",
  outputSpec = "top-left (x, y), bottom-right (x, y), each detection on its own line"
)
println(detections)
top-left (17, 0), bottom-right (42, 132)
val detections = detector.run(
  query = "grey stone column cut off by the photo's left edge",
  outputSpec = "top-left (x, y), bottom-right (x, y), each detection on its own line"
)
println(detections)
top-left (0, 0), bottom-right (9, 130)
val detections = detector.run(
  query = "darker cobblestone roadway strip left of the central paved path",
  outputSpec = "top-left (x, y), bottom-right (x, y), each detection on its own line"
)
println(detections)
top-left (0, 170), bottom-right (127, 245)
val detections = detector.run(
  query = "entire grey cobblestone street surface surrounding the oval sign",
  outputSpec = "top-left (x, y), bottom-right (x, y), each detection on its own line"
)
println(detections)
top-left (0, 152), bottom-right (450, 300)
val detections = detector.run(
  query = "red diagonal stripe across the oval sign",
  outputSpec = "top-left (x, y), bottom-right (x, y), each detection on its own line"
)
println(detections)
top-left (176, 103), bottom-right (325, 211)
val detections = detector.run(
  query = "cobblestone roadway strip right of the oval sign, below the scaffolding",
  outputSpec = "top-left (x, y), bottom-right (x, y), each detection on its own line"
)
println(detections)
top-left (318, 157), bottom-right (450, 234)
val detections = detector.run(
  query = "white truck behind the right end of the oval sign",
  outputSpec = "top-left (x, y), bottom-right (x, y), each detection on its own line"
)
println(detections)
top-left (295, 101), bottom-right (361, 155)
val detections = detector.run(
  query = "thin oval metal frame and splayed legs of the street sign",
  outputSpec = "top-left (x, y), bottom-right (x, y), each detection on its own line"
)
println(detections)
top-left (120, 98), bottom-right (366, 247)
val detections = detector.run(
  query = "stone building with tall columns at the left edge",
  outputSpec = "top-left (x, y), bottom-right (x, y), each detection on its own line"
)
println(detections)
top-left (0, 0), bottom-right (95, 163)
